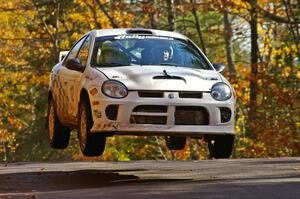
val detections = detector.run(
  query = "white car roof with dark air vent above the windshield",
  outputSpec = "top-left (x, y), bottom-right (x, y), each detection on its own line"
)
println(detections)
top-left (91, 28), bottom-right (188, 40)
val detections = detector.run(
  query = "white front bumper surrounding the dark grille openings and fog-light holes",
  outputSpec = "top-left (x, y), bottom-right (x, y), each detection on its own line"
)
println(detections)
top-left (90, 91), bottom-right (235, 136)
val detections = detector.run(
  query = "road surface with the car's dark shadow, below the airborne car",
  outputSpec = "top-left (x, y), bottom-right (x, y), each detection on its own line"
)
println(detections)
top-left (0, 158), bottom-right (300, 199)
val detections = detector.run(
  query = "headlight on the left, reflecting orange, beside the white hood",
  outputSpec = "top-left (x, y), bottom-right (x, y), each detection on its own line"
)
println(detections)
top-left (102, 80), bottom-right (128, 98)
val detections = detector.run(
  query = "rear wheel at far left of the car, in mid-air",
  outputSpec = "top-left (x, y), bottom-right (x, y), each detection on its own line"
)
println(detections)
top-left (47, 99), bottom-right (71, 149)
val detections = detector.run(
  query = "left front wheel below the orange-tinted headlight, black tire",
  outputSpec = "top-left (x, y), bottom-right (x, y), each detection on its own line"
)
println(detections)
top-left (78, 101), bottom-right (106, 156)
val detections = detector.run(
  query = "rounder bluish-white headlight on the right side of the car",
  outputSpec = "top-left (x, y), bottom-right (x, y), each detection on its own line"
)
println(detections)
top-left (210, 82), bottom-right (231, 101)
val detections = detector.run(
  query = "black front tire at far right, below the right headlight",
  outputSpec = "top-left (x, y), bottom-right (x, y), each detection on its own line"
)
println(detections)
top-left (208, 135), bottom-right (235, 159)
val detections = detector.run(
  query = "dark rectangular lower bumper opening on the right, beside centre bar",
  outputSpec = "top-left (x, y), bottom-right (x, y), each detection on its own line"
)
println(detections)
top-left (175, 106), bottom-right (209, 125)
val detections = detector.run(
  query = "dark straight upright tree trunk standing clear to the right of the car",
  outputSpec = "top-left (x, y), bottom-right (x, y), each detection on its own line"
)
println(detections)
top-left (247, 0), bottom-right (259, 138)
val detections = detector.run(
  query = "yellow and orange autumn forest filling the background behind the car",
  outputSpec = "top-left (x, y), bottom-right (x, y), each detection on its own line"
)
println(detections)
top-left (0, 0), bottom-right (300, 161)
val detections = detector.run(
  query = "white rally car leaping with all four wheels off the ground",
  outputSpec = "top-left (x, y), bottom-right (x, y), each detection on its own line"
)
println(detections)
top-left (47, 29), bottom-right (236, 158)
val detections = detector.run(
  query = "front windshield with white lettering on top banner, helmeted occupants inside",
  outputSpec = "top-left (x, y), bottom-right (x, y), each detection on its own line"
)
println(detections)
top-left (92, 35), bottom-right (212, 70)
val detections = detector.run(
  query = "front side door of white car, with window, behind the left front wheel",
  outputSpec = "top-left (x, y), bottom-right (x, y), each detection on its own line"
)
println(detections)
top-left (59, 36), bottom-right (91, 125)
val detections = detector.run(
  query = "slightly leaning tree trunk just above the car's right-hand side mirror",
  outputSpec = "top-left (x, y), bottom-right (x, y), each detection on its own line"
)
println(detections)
top-left (223, 4), bottom-right (235, 81)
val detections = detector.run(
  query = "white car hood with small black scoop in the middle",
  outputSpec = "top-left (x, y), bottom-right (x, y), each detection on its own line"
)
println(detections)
top-left (98, 66), bottom-right (222, 91)
